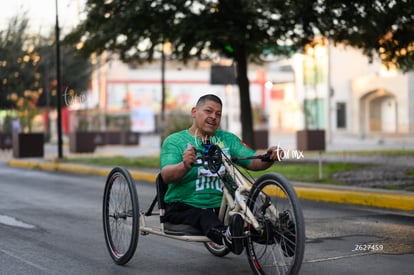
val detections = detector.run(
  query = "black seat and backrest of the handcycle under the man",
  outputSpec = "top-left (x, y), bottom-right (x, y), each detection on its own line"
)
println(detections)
top-left (156, 174), bottom-right (204, 236)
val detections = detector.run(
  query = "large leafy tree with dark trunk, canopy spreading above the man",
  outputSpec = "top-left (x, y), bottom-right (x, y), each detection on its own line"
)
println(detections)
top-left (65, 0), bottom-right (414, 146)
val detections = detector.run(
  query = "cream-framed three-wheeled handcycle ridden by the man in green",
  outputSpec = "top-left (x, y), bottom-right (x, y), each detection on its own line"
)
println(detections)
top-left (102, 144), bottom-right (305, 274)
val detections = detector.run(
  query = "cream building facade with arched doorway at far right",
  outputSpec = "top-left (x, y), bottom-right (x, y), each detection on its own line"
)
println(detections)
top-left (330, 47), bottom-right (414, 137)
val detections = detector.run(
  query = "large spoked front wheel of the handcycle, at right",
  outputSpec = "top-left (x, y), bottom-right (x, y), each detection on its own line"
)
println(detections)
top-left (246, 173), bottom-right (305, 275)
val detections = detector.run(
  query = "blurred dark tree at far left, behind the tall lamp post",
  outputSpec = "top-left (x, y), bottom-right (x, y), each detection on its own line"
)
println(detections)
top-left (0, 13), bottom-right (92, 109)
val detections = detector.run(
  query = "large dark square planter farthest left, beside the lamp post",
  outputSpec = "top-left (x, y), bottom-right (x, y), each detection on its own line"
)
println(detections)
top-left (13, 133), bottom-right (44, 158)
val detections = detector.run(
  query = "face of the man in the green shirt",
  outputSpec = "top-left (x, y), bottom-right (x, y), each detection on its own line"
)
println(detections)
top-left (191, 100), bottom-right (222, 136)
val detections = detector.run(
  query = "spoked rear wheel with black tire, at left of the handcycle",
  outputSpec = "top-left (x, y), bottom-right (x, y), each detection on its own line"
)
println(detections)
top-left (102, 167), bottom-right (140, 265)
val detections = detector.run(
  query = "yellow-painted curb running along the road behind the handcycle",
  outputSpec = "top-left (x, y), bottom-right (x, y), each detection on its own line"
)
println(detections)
top-left (8, 159), bottom-right (414, 211)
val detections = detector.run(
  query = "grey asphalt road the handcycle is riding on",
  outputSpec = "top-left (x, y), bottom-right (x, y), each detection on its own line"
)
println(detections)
top-left (0, 165), bottom-right (414, 275)
